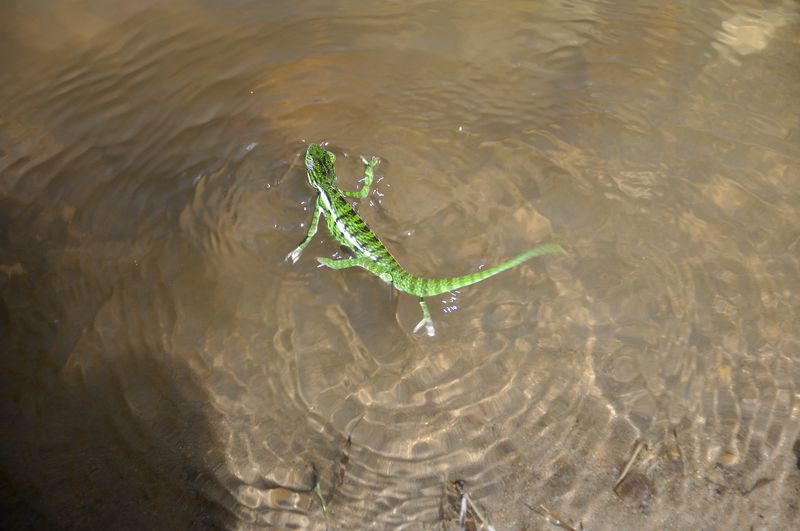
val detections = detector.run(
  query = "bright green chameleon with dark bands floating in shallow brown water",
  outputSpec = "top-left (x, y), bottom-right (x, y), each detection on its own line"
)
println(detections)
top-left (286, 144), bottom-right (564, 336)
